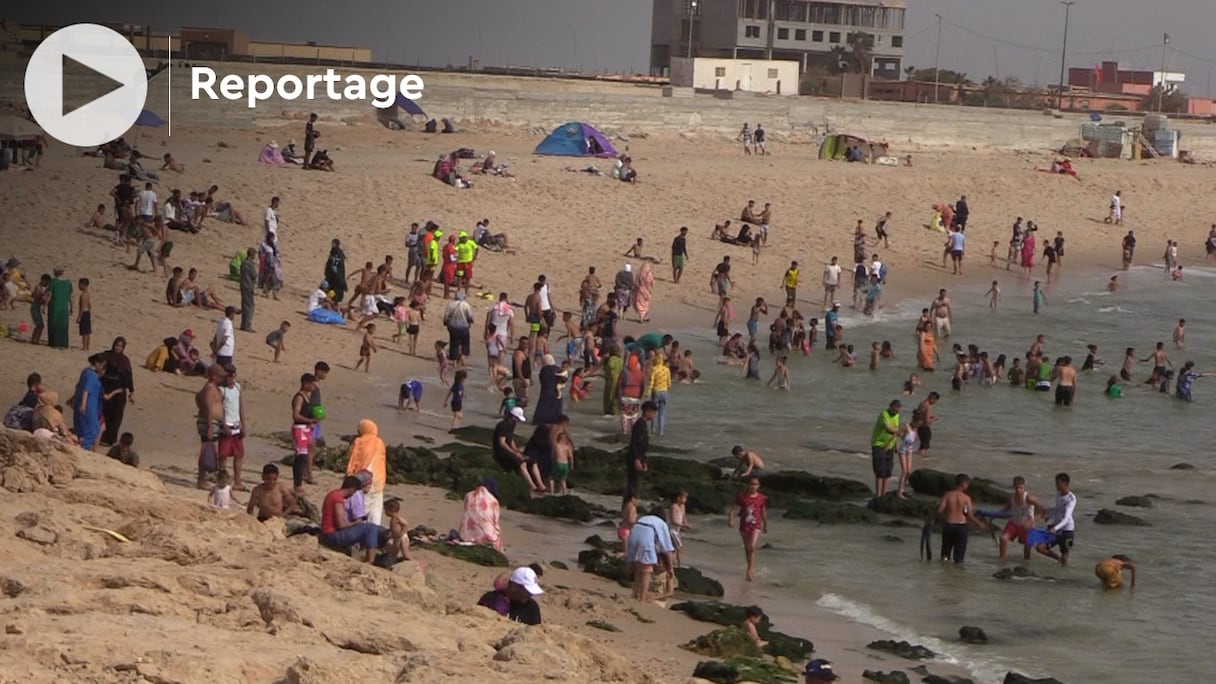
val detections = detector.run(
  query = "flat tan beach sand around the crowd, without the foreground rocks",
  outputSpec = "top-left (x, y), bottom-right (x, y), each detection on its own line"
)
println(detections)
top-left (0, 119), bottom-right (1211, 682)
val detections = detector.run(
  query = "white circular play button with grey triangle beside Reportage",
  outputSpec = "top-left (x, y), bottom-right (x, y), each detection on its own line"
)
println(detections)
top-left (26, 24), bottom-right (148, 147)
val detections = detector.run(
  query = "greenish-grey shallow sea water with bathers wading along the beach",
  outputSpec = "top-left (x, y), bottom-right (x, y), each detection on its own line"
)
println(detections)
top-left (605, 267), bottom-right (1216, 683)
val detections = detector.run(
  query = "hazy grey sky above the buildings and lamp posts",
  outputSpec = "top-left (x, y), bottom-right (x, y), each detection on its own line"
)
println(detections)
top-left (5, 0), bottom-right (1216, 95)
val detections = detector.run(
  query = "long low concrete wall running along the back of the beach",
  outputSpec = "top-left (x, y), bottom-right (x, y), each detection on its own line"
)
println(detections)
top-left (0, 58), bottom-right (1216, 159)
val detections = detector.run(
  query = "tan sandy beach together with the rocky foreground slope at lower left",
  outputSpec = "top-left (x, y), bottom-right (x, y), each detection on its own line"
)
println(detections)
top-left (0, 105), bottom-right (1216, 683)
